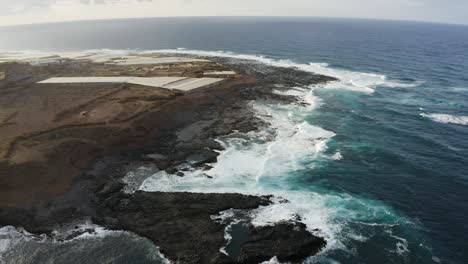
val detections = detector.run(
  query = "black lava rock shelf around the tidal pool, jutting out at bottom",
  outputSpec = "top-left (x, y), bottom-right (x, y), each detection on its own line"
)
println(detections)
top-left (93, 192), bottom-right (326, 263)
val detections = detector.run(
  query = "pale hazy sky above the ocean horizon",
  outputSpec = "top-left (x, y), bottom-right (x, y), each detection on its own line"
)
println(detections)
top-left (0, 0), bottom-right (468, 26)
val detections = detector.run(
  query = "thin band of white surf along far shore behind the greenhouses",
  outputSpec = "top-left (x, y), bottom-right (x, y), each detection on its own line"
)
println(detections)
top-left (0, 48), bottom-right (423, 93)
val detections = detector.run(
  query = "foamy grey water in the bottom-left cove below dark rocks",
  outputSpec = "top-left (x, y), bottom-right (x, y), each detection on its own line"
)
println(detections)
top-left (0, 222), bottom-right (171, 264)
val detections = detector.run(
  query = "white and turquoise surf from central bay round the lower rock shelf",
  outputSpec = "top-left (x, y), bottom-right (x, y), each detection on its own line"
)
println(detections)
top-left (140, 81), bottom-right (410, 261)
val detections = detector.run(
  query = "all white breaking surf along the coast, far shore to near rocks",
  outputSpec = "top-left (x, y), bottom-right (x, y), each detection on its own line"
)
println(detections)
top-left (0, 49), bottom-right (428, 263)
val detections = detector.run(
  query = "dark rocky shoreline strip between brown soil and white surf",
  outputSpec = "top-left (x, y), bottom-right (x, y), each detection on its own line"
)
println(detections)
top-left (0, 52), bottom-right (333, 263)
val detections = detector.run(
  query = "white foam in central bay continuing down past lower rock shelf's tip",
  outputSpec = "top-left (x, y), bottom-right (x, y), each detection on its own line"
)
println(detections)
top-left (140, 89), bottom-right (338, 252)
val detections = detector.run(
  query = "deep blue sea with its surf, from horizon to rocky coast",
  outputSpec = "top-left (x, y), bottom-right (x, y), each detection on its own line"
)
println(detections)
top-left (0, 18), bottom-right (468, 264)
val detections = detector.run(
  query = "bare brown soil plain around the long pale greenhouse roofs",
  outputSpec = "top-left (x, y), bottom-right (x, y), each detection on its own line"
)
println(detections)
top-left (0, 58), bottom-right (247, 207)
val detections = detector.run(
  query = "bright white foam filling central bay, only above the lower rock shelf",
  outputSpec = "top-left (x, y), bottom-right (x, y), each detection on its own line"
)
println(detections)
top-left (141, 86), bottom-right (335, 192)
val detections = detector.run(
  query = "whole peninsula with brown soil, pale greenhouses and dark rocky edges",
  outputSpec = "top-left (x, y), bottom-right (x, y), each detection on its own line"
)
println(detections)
top-left (0, 52), bottom-right (334, 263)
